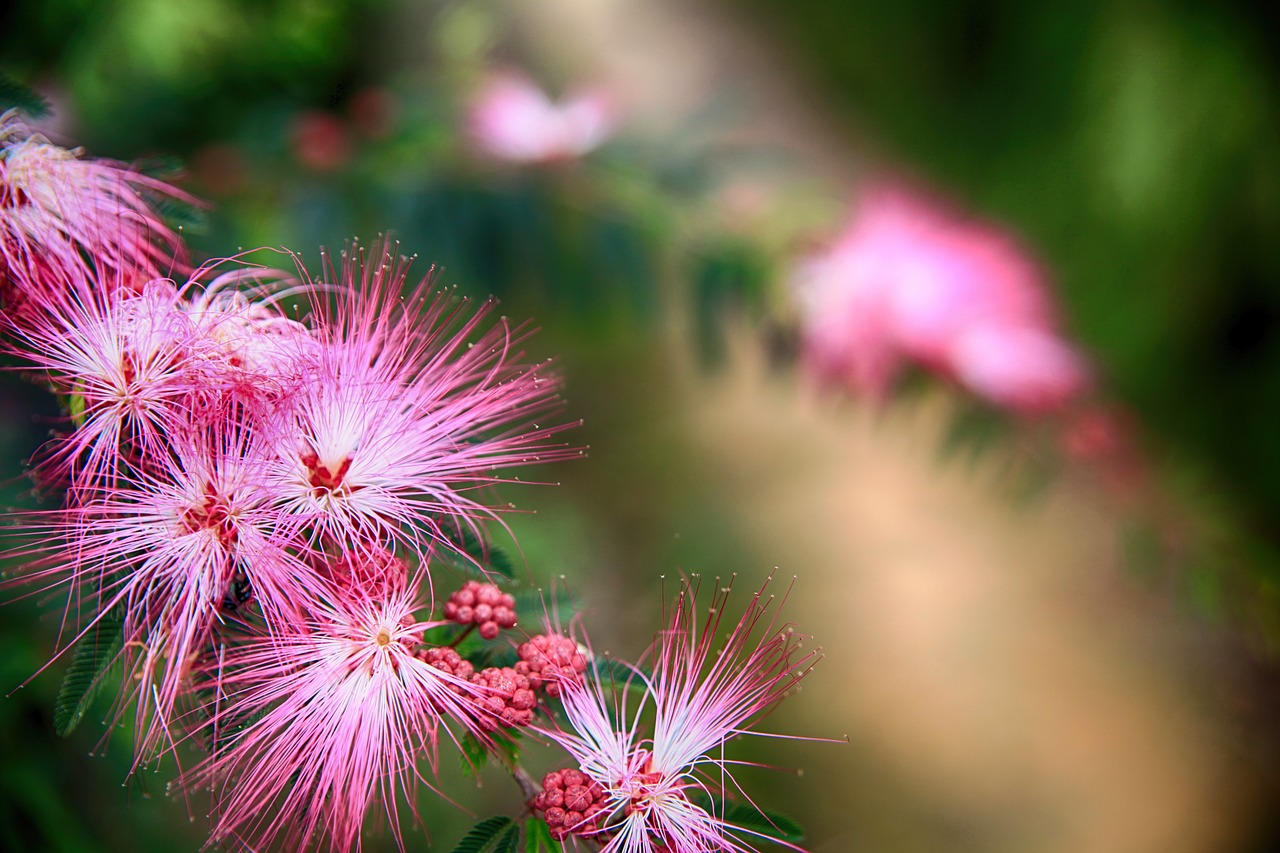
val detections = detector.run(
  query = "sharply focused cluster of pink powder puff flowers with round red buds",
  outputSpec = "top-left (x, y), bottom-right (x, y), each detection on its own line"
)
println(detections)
top-left (0, 111), bottom-right (813, 852)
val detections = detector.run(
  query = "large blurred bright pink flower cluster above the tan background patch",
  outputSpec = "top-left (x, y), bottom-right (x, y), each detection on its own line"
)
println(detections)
top-left (794, 184), bottom-right (1088, 414)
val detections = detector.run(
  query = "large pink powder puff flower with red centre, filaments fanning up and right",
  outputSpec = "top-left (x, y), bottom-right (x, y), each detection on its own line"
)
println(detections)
top-left (264, 246), bottom-right (579, 557)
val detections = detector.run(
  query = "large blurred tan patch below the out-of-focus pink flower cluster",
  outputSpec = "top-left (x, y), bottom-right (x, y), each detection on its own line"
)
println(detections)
top-left (685, 325), bottom-right (1249, 853)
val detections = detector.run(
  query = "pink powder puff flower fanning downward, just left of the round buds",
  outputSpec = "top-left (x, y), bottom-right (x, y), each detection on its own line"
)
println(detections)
top-left (182, 555), bottom-right (488, 850)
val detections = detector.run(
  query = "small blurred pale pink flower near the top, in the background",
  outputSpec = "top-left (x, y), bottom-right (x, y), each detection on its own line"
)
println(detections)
top-left (468, 72), bottom-right (614, 163)
